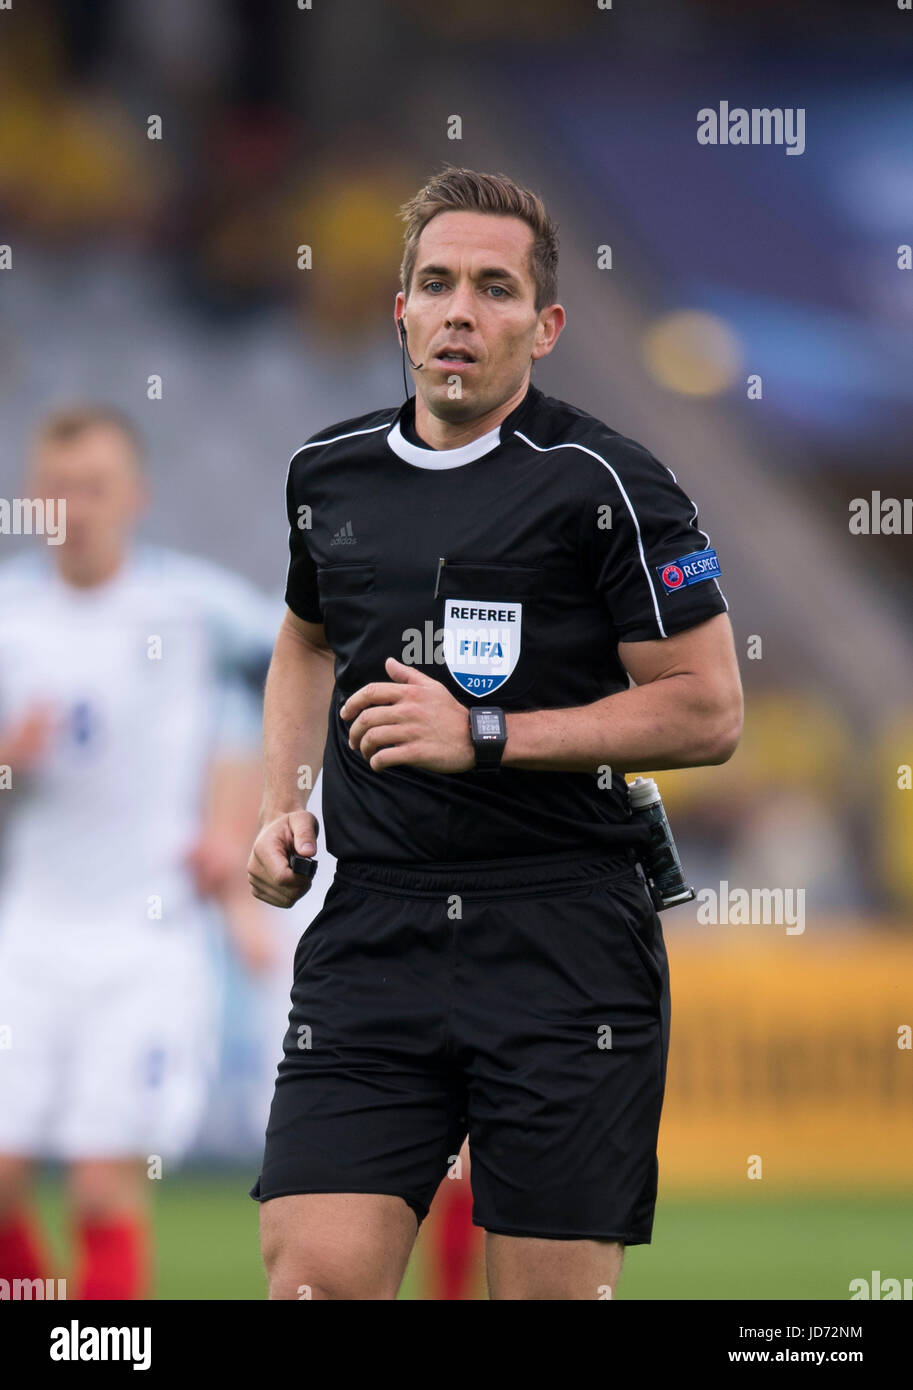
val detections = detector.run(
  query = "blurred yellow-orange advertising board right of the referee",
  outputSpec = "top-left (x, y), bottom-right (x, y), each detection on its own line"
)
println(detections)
top-left (659, 928), bottom-right (913, 1193)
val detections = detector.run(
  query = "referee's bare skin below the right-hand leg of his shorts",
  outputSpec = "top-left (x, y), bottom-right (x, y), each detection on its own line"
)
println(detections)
top-left (485, 1233), bottom-right (624, 1300)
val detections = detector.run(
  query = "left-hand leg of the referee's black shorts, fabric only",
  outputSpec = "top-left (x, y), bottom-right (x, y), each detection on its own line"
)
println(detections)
top-left (250, 878), bottom-right (466, 1245)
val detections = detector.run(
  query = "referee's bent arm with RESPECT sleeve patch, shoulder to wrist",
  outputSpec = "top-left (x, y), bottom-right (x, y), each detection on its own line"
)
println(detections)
top-left (502, 438), bottom-right (742, 773)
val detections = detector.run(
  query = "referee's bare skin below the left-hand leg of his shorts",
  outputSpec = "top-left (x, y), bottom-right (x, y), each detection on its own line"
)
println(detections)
top-left (260, 1193), bottom-right (418, 1301)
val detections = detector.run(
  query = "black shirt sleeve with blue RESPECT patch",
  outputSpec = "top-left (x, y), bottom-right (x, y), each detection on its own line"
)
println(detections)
top-left (579, 436), bottom-right (730, 642)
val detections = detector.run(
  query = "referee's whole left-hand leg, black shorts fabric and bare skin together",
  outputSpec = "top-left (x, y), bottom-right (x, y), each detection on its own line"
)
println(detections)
top-left (250, 865), bottom-right (467, 1300)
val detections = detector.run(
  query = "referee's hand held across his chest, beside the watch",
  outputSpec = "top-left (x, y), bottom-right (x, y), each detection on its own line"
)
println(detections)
top-left (339, 656), bottom-right (475, 773)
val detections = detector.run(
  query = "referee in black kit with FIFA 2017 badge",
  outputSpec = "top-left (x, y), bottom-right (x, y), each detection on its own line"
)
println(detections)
top-left (249, 167), bottom-right (742, 1300)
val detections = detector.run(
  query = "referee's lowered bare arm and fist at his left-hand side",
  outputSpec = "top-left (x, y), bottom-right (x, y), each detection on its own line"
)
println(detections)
top-left (247, 609), bottom-right (334, 908)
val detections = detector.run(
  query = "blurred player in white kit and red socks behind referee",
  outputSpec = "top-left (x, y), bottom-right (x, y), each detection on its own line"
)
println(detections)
top-left (0, 407), bottom-right (275, 1298)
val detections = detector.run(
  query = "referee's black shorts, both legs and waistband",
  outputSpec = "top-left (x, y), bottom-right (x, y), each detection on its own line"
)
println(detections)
top-left (250, 852), bottom-right (670, 1245)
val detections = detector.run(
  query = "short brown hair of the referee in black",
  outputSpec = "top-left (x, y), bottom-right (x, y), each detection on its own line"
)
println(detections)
top-left (399, 164), bottom-right (559, 311)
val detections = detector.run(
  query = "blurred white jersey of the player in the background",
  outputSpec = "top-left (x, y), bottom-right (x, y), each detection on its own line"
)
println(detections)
top-left (0, 543), bottom-right (278, 940)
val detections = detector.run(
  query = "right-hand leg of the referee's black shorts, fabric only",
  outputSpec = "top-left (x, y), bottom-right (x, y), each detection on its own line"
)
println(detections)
top-left (454, 873), bottom-right (670, 1251)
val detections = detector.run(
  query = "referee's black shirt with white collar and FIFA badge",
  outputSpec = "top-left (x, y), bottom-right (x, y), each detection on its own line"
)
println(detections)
top-left (285, 385), bottom-right (728, 863)
